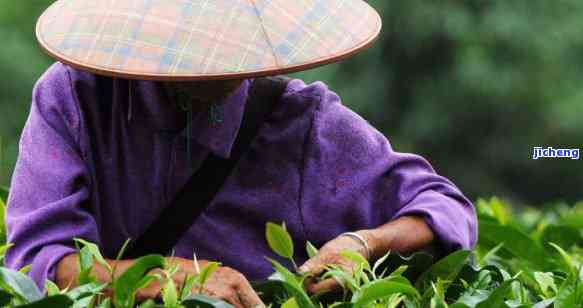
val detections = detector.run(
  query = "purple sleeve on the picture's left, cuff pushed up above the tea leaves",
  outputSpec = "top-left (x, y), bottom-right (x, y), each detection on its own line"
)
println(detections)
top-left (5, 63), bottom-right (99, 289)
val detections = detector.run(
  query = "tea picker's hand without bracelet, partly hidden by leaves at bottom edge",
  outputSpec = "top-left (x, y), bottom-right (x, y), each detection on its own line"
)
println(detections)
top-left (136, 257), bottom-right (265, 308)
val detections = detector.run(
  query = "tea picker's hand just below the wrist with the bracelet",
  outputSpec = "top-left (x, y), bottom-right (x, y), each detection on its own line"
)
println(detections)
top-left (299, 232), bottom-right (368, 294)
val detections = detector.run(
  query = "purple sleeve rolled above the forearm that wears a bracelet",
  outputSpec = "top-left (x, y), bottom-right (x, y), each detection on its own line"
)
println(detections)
top-left (297, 82), bottom-right (477, 253)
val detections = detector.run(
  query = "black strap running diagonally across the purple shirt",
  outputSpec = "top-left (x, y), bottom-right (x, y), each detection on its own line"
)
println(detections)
top-left (124, 76), bottom-right (290, 258)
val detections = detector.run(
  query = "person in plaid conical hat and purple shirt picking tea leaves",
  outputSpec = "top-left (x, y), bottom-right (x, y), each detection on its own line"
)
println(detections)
top-left (6, 0), bottom-right (477, 307)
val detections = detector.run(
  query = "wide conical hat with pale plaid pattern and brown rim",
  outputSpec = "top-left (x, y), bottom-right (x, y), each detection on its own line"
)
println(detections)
top-left (36, 0), bottom-right (381, 81)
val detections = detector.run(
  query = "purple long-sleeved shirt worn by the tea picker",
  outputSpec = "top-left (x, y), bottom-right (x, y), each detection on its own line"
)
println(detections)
top-left (6, 63), bottom-right (477, 288)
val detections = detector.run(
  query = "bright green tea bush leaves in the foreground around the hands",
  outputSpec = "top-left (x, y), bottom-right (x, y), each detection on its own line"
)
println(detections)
top-left (0, 192), bottom-right (583, 308)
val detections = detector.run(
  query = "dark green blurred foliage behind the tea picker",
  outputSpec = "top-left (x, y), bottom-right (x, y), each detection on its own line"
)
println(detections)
top-left (0, 0), bottom-right (583, 204)
